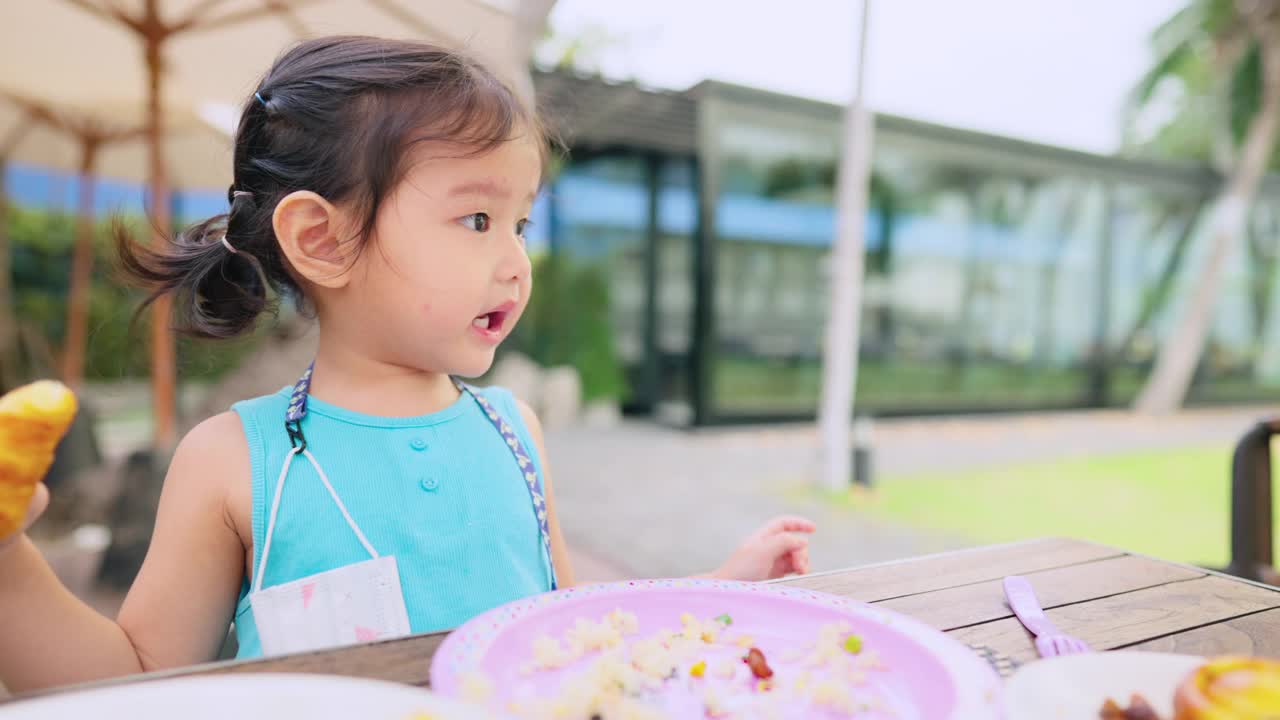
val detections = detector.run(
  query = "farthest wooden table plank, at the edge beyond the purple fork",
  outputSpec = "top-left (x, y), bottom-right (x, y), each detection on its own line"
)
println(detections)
top-left (786, 538), bottom-right (1125, 602)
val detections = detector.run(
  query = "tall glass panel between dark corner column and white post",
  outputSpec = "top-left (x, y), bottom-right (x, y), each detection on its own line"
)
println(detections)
top-left (712, 106), bottom-right (838, 415)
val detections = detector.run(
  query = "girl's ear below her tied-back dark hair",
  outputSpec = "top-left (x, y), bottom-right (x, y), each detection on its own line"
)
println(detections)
top-left (271, 190), bottom-right (349, 288)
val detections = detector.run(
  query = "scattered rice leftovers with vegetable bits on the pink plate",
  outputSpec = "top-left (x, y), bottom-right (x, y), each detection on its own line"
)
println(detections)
top-left (483, 610), bottom-right (882, 720)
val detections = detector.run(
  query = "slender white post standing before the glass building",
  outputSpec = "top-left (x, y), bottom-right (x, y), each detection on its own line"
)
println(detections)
top-left (818, 0), bottom-right (873, 491)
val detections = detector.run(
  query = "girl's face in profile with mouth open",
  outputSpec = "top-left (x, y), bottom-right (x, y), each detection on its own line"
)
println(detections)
top-left (337, 138), bottom-right (541, 377)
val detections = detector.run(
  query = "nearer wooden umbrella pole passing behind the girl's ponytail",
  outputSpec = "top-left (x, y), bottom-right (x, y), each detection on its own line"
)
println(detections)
top-left (145, 32), bottom-right (178, 451)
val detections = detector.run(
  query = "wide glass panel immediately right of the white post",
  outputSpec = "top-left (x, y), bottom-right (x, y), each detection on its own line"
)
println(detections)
top-left (858, 142), bottom-right (1105, 413)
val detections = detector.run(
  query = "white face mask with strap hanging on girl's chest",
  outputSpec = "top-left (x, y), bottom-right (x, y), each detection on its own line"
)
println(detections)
top-left (250, 447), bottom-right (410, 655)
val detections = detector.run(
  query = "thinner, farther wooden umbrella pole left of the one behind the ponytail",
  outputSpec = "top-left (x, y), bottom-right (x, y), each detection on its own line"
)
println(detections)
top-left (63, 135), bottom-right (101, 388)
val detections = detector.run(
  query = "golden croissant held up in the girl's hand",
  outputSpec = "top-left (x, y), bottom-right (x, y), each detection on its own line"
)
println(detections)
top-left (0, 380), bottom-right (77, 538)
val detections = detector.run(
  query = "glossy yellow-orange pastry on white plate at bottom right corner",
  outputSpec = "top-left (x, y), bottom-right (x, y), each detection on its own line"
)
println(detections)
top-left (1174, 656), bottom-right (1280, 720)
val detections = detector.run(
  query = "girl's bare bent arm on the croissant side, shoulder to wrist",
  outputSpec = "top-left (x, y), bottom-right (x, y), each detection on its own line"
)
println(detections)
top-left (0, 413), bottom-right (250, 692)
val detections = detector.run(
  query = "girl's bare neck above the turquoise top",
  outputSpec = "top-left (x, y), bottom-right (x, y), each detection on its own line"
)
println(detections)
top-left (303, 326), bottom-right (458, 418)
